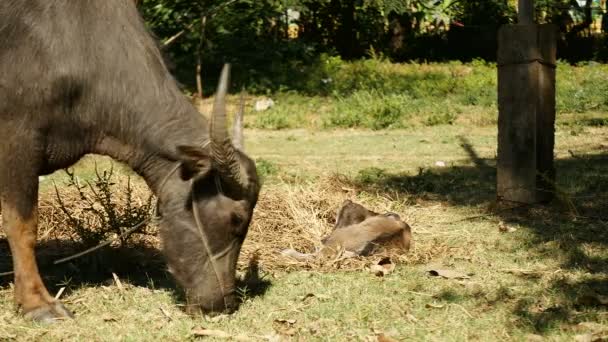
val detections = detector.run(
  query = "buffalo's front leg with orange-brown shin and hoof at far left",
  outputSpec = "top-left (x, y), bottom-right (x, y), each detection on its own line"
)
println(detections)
top-left (0, 180), bottom-right (73, 323)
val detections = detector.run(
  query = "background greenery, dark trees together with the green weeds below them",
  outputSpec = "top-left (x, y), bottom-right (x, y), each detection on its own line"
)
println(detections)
top-left (139, 0), bottom-right (608, 129)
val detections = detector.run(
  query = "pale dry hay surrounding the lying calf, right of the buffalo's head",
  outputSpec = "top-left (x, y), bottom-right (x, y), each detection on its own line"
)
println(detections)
top-left (242, 177), bottom-right (426, 271)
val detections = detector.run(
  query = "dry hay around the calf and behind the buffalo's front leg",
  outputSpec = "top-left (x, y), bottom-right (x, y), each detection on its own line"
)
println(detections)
top-left (0, 176), bottom-right (446, 272)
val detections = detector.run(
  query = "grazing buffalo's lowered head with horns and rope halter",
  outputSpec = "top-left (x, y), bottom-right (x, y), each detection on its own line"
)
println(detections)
top-left (159, 67), bottom-right (260, 313)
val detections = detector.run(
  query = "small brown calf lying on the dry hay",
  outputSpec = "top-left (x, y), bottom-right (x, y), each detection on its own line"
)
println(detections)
top-left (281, 200), bottom-right (412, 260)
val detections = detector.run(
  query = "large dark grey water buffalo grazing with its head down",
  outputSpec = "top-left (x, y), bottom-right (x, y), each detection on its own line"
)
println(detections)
top-left (0, 0), bottom-right (260, 322)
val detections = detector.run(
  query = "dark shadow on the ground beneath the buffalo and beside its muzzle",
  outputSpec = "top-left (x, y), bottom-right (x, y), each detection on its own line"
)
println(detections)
top-left (0, 238), bottom-right (271, 310)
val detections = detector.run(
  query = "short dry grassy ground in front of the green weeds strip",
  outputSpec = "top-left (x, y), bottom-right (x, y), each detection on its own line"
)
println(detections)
top-left (0, 120), bottom-right (608, 341)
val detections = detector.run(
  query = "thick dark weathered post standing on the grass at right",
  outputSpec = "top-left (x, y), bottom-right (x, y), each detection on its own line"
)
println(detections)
top-left (496, 0), bottom-right (557, 203)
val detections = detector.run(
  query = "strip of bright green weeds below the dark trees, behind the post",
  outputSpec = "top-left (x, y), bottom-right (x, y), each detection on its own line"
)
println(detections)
top-left (248, 57), bottom-right (608, 130)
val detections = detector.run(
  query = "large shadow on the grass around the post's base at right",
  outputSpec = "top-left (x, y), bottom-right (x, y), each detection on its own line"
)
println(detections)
top-left (346, 138), bottom-right (608, 333)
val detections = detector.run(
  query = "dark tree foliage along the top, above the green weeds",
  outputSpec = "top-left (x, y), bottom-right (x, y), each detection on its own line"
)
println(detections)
top-left (138, 0), bottom-right (608, 96)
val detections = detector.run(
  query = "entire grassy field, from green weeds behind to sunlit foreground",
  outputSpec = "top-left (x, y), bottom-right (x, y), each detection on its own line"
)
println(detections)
top-left (0, 56), bottom-right (608, 341)
